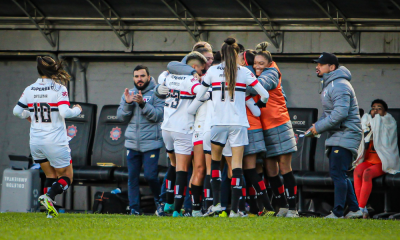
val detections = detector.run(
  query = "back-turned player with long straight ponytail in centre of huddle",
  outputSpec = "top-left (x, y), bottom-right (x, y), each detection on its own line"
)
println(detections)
top-left (196, 38), bottom-right (268, 217)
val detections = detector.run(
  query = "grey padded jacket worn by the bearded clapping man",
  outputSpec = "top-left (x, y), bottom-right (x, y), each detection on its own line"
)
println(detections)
top-left (117, 77), bottom-right (164, 152)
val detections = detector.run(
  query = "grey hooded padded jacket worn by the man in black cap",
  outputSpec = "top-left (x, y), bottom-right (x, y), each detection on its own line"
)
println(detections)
top-left (315, 66), bottom-right (362, 159)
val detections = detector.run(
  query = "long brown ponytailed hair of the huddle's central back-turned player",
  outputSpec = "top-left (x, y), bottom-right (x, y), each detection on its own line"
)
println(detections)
top-left (221, 38), bottom-right (239, 97)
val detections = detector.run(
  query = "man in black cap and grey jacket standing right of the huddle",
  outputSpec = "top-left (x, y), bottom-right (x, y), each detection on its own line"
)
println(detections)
top-left (310, 52), bottom-right (362, 218)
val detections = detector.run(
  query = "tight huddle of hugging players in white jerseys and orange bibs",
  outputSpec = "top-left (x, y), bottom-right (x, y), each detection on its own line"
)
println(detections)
top-left (156, 38), bottom-right (299, 217)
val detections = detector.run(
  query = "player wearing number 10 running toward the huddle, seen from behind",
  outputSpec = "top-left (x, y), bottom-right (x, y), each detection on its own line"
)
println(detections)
top-left (13, 56), bottom-right (82, 218)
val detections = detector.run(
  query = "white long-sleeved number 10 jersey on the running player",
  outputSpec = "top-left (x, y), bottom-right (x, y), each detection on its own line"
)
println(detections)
top-left (18, 78), bottom-right (80, 145)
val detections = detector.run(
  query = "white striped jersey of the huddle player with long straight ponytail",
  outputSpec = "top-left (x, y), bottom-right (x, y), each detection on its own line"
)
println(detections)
top-left (203, 63), bottom-right (262, 127)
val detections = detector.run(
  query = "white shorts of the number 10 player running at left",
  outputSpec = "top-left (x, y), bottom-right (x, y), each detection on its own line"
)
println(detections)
top-left (30, 145), bottom-right (72, 168)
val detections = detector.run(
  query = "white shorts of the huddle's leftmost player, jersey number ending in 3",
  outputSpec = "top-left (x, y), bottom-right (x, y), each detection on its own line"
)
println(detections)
top-left (162, 130), bottom-right (193, 155)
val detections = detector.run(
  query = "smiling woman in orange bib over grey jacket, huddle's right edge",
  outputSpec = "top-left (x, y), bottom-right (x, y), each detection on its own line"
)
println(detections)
top-left (253, 42), bottom-right (299, 217)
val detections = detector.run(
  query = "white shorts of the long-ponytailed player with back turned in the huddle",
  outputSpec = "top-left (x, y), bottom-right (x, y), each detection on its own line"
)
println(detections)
top-left (211, 126), bottom-right (249, 147)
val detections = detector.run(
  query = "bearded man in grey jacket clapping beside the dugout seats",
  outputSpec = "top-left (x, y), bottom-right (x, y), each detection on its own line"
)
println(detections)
top-left (117, 65), bottom-right (165, 216)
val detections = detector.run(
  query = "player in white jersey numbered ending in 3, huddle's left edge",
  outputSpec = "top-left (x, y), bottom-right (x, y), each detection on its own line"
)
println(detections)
top-left (158, 51), bottom-right (207, 217)
